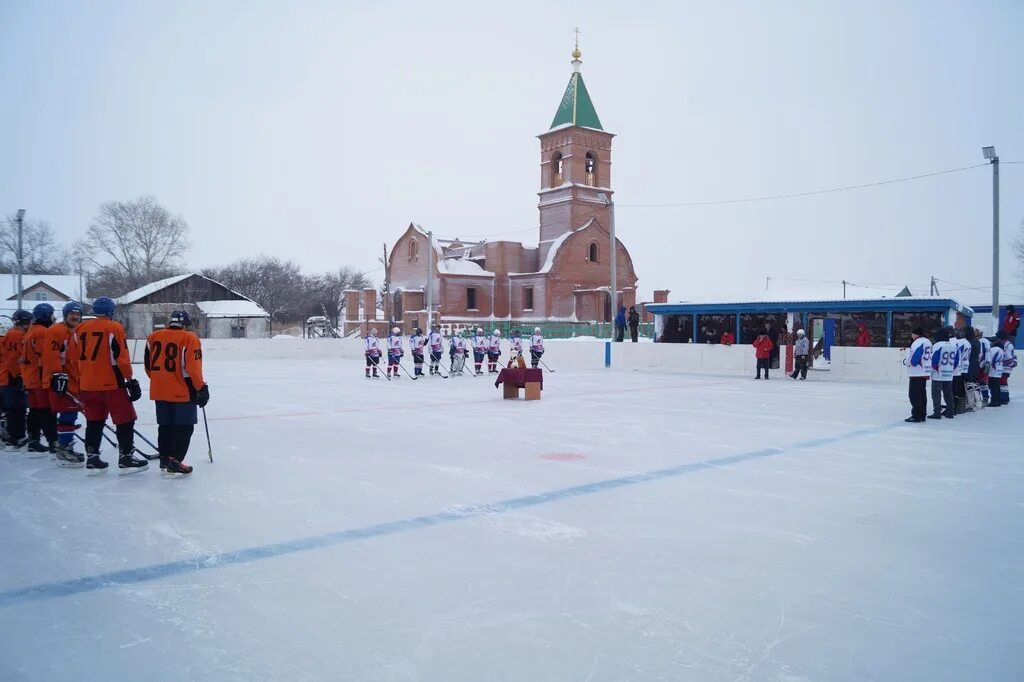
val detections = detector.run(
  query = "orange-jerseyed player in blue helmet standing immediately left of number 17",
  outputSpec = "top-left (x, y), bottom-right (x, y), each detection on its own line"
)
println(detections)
top-left (43, 301), bottom-right (85, 467)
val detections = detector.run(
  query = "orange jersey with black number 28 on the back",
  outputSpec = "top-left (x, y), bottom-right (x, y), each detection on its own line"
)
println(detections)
top-left (145, 328), bottom-right (206, 402)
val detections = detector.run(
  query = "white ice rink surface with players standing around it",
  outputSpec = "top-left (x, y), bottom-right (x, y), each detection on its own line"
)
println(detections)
top-left (0, 360), bottom-right (1024, 682)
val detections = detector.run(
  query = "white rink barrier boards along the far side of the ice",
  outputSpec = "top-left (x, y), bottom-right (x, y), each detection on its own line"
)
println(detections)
top-left (138, 338), bottom-right (906, 383)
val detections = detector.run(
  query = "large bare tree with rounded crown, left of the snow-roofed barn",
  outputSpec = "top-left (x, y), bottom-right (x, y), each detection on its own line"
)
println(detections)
top-left (82, 197), bottom-right (188, 295)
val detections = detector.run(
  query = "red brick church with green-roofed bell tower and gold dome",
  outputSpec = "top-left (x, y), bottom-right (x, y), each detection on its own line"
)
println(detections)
top-left (388, 47), bottom-right (637, 326)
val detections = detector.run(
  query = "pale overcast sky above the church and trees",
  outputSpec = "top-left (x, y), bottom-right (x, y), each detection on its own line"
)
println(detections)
top-left (0, 0), bottom-right (1024, 303)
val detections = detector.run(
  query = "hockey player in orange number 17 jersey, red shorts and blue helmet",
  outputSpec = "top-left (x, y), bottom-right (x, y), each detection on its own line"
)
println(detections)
top-left (71, 296), bottom-right (150, 474)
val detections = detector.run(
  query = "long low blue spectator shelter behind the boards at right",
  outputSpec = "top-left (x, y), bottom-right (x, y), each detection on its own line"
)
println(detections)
top-left (647, 296), bottom-right (974, 347)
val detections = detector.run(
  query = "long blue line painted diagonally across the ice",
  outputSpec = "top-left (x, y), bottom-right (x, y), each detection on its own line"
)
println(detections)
top-left (0, 422), bottom-right (902, 608)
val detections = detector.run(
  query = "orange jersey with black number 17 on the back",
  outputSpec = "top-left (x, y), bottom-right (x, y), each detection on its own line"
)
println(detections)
top-left (70, 317), bottom-right (132, 391)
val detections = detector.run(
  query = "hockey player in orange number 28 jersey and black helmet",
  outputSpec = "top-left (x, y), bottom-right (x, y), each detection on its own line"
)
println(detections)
top-left (145, 310), bottom-right (210, 474)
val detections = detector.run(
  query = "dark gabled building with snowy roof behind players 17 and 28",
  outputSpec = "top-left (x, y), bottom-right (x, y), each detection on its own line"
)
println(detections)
top-left (115, 272), bottom-right (270, 339)
